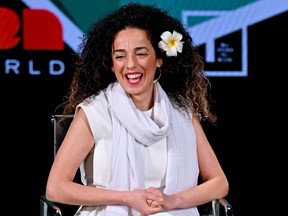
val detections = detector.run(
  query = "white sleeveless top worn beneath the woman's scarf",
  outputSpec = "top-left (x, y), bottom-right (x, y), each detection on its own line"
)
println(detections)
top-left (75, 92), bottom-right (170, 216)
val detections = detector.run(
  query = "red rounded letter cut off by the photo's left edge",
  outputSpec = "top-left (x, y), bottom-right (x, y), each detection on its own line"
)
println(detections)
top-left (0, 7), bottom-right (20, 50)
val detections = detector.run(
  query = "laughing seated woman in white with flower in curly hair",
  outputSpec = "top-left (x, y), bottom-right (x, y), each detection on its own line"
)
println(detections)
top-left (46, 3), bottom-right (228, 216)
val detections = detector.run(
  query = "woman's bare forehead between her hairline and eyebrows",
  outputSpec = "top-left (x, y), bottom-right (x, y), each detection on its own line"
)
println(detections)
top-left (114, 28), bottom-right (151, 46)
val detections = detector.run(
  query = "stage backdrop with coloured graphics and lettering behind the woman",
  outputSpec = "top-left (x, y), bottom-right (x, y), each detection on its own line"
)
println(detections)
top-left (0, 0), bottom-right (288, 216)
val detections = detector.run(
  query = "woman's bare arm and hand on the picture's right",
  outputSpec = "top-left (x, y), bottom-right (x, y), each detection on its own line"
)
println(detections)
top-left (148, 118), bottom-right (229, 210)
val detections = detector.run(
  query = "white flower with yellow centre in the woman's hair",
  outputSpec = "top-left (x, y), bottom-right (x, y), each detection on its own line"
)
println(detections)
top-left (158, 31), bottom-right (184, 56)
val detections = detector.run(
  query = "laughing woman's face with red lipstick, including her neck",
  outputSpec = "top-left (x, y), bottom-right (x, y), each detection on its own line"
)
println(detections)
top-left (112, 28), bottom-right (162, 110)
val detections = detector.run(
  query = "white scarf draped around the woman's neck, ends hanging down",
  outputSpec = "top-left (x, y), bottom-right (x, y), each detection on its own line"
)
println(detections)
top-left (106, 83), bottom-right (199, 216)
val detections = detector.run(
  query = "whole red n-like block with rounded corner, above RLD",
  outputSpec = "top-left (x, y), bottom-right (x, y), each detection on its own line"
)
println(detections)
top-left (23, 9), bottom-right (64, 50)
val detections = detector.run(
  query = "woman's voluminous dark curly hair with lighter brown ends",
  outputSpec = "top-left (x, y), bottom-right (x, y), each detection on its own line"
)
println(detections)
top-left (62, 3), bottom-right (216, 123)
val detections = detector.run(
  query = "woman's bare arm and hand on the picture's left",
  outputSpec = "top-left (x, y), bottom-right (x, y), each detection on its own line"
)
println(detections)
top-left (46, 109), bottom-right (164, 214)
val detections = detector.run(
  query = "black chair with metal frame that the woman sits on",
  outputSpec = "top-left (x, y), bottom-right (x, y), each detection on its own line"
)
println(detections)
top-left (40, 115), bottom-right (234, 216)
